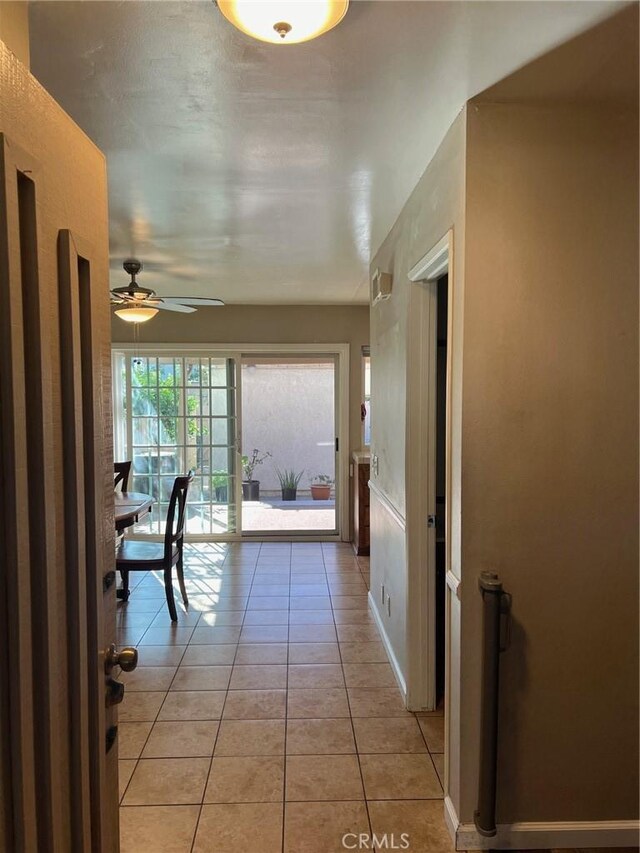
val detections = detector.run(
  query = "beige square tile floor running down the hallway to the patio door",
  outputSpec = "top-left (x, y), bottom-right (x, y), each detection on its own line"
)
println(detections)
top-left (118, 543), bottom-right (444, 853)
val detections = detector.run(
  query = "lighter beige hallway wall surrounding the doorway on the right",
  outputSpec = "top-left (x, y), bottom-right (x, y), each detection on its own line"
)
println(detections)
top-left (371, 106), bottom-right (466, 801)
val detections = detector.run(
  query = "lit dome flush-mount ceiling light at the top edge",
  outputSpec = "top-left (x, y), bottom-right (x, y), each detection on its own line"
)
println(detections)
top-left (217, 0), bottom-right (349, 44)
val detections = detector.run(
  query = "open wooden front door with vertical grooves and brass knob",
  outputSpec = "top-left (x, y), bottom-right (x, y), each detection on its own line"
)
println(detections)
top-left (0, 42), bottom-right (118, 853)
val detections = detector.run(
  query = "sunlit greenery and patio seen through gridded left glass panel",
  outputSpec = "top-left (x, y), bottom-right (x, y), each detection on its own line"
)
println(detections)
top-left (116, 354), bottom-right (237, 537)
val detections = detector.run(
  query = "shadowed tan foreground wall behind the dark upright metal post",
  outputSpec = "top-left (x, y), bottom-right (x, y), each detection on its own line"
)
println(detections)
top-left (461, 103), bottom-right (638, 822)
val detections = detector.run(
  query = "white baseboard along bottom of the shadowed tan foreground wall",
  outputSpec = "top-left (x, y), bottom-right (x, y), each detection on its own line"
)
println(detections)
top-left (444, 797), bottom-right (640, 850)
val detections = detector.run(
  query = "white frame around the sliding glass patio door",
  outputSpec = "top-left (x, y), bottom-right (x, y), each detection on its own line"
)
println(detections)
top-left (113, 341), bottom-right (351, 542)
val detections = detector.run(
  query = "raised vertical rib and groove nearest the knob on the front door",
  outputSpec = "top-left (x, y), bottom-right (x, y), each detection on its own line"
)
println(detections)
top-left (58, 230), bottom-right (117, 850)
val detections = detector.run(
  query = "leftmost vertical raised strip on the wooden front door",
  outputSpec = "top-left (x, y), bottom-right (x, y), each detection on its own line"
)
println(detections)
top-left (0, 134), bottom-right (37, 850)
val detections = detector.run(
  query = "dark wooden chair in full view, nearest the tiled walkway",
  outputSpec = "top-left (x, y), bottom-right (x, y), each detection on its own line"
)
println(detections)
top-left (116, 471), bottom-right (193, 622)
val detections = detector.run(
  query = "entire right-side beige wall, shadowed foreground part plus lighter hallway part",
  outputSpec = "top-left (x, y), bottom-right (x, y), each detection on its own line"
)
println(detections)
top-left (371, 8), bottom-right (638, 825)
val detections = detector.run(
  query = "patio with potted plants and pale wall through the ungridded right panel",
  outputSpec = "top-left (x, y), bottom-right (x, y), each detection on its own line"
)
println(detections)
top-left (240, 355), bottom-right (338, 534)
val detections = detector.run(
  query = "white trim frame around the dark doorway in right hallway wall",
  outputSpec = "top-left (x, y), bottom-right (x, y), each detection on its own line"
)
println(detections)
top-left (406, 230), bottom-right (454, 711)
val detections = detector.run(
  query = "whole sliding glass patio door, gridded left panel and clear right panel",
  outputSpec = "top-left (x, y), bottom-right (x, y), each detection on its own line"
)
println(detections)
top-left (113, 344), bottom-right (349, 539)
